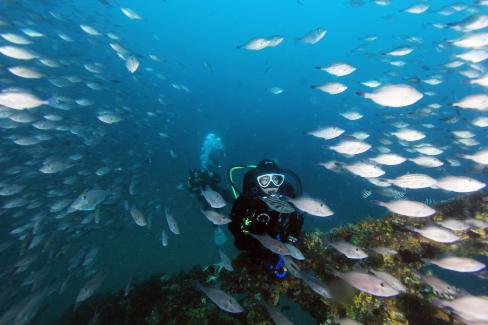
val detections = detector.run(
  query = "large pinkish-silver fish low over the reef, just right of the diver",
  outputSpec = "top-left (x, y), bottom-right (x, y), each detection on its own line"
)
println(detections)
top-left (332, 271), bottom-right (400, 297)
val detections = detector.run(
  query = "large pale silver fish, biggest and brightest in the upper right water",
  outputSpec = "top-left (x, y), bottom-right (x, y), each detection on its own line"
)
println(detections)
top-left (356, 84), bottom-right (424, 108)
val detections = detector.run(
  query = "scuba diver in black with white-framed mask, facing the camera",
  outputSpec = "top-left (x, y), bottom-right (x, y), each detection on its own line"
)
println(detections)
top-left (229, 159), bottom-right (303, 278)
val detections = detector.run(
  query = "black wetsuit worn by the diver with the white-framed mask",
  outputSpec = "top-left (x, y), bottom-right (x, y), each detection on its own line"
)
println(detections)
top-left (229, 166), bottom-right (303, 255)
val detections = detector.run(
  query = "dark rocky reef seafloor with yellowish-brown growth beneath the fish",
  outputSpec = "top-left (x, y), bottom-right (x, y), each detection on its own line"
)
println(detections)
top-left (61, 192), bottom-right (488, 325)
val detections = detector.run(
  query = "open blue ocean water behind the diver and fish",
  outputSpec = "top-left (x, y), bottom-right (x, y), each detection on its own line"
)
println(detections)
top-left (0, 0), bottom-right (488, 324)
